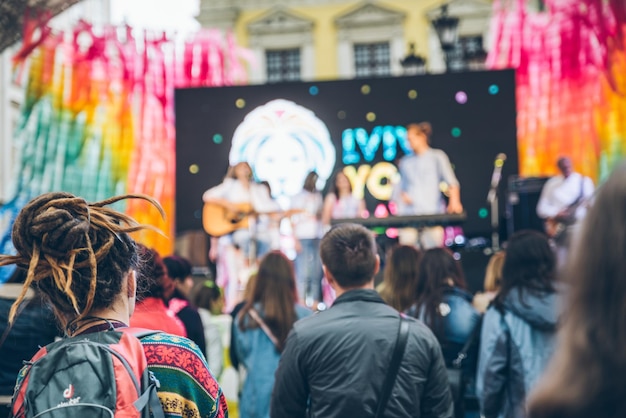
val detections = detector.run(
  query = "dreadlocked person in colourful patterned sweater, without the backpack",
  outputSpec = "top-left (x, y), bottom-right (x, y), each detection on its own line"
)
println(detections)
top-left (0, 192), bottom-right (228, 417)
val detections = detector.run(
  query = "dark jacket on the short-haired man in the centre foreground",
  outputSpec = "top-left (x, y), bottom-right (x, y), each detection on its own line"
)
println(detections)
top-left (270, 289), bottom-right (453, 418)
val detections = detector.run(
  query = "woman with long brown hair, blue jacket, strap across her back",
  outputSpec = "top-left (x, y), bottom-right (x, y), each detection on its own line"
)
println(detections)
top-left (233, 251), bottom-right (311, 418)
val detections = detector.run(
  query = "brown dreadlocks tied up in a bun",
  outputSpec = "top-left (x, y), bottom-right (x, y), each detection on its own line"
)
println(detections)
top-left (0, 192), bottom-right (165, 328)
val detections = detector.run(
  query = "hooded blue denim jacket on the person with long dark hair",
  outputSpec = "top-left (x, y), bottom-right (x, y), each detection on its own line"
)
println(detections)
top-left (476, 289), bottom-right (558, 418)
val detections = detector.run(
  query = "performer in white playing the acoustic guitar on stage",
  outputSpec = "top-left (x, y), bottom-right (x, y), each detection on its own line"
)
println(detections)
top-left (202, 162), bottom-right (279, 310)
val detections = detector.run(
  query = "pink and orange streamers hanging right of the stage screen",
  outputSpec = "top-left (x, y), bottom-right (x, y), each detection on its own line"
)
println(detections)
top-left (487, 0), bottom-right (626, 179)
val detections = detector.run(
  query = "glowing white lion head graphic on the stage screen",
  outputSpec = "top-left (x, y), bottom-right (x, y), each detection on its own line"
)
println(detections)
top-left (229, 99), bottom-right (336, 201)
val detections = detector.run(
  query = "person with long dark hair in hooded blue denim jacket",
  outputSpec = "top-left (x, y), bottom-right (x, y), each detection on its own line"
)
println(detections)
top-left (476, 230), bottom-right (558, 418)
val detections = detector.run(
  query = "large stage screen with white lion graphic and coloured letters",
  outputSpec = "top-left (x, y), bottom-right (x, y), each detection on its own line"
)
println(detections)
top-left (175, 70), bottom-right (518, 237)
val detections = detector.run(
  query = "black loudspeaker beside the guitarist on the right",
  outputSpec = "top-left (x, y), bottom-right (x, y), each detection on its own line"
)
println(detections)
top-left (506, 176), bottom-right (550, 236)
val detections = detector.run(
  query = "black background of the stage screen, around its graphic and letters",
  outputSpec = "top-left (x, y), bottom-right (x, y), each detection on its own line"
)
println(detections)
top-left (175, 70), bottom-right (518, 237)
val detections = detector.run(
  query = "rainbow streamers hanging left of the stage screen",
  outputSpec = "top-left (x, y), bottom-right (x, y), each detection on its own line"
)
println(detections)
top-left (0, 21), bottom-right (249, 282)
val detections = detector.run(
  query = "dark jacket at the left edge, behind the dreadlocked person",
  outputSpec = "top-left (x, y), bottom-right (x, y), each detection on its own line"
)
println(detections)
top-left (0, 284), bottom-right (61, 396)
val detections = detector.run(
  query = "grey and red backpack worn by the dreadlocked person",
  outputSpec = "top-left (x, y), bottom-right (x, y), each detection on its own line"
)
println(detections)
top-left (11, 328), bottom-right (165, 418)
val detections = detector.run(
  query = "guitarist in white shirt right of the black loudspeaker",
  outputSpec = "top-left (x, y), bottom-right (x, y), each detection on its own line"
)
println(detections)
top-left (537, 157), bottom-right (594, 266)
